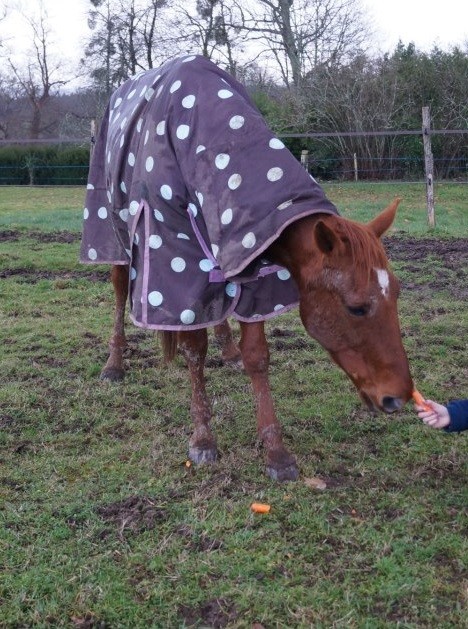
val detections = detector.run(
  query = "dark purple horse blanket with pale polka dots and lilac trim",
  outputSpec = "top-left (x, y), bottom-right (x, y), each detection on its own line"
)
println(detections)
top-left (80, 56), bottom-right (337, 330)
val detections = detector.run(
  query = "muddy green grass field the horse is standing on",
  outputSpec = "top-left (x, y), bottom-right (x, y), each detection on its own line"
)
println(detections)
top-left (0, 184), bottom-right (468, 629)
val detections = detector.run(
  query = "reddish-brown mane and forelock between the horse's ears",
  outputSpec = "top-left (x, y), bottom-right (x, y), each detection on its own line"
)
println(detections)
top-left (338, 217), bottom-right (388, 278)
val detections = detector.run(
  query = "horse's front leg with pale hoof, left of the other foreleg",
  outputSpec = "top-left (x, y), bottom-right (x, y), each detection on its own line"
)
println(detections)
top-left (178, 329), bottom-right (217, 463)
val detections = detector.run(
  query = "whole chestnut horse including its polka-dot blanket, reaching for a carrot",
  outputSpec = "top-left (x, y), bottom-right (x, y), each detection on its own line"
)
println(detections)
top-left (81, 56), bottom-right (413, 480)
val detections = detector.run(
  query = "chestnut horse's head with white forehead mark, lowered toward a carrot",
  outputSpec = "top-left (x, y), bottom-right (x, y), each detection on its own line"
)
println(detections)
top-left (276, 199), bottom-right (413, 413)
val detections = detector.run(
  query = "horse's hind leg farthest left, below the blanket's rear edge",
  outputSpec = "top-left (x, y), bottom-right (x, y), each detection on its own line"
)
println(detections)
top-left (101, 264), bottom-right (128, 382)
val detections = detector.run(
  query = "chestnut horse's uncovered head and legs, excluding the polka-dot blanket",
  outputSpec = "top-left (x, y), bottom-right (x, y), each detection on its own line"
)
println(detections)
top-left (100, 199), bottom-right (413, 481)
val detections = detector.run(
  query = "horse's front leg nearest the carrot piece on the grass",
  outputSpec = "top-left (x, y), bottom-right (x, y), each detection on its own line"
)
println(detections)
top-left (240, 321), bottom-right (299, 481)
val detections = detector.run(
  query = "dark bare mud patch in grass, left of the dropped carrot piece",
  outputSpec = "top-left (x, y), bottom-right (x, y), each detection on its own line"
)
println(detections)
top-left (96, 496), bottom-right (167, 537)
